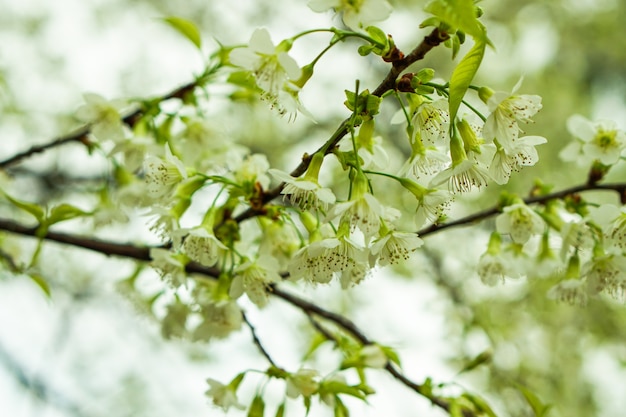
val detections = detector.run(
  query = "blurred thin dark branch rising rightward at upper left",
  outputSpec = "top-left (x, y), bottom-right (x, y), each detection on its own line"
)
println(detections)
top-left (0, 81), bottom-right (197, 169)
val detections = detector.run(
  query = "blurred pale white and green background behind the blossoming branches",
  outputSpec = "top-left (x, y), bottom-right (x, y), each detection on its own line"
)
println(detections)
top-left (0, 0), bottom-right (626, 417)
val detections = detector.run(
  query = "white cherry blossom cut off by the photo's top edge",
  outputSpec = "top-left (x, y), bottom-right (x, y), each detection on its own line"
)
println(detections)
top-left (309, 0), bottom-right (391, 30)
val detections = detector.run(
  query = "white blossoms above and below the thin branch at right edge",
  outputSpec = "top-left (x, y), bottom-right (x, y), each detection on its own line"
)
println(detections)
top-left (478, 115), bottom-right (626, 305)
